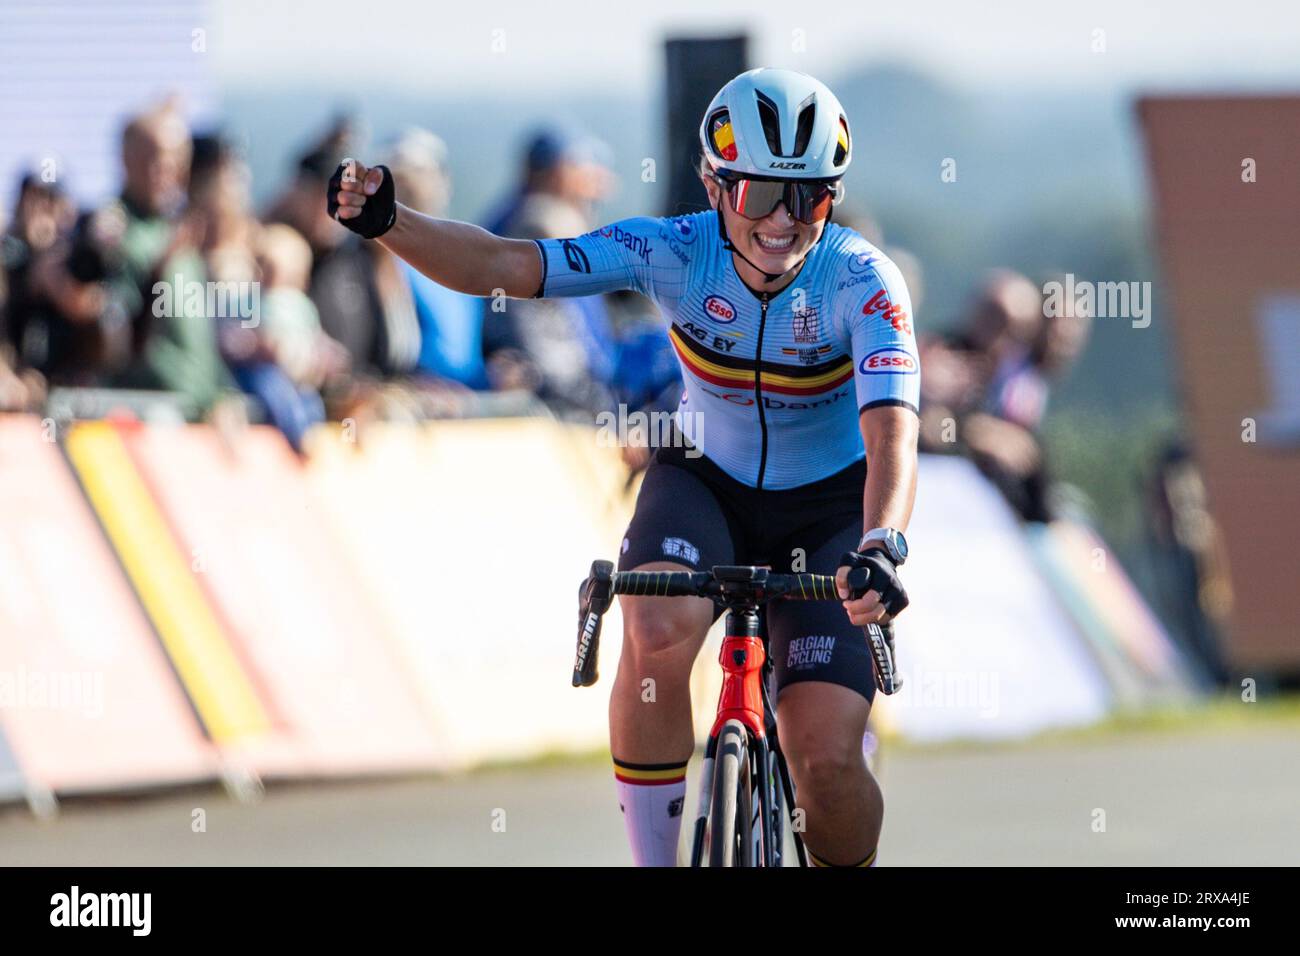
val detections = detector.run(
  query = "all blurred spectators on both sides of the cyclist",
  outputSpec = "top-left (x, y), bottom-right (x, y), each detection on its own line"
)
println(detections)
top-left (0, 95), bottom-right (1227, 679)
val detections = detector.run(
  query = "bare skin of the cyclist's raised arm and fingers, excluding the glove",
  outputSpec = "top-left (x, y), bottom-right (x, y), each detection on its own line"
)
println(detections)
top-left (338, 163), bottom-right (542, 299)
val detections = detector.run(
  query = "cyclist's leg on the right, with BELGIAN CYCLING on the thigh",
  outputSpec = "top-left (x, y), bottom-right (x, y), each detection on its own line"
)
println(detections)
top-left (768, 518), bottom-right (884, 866)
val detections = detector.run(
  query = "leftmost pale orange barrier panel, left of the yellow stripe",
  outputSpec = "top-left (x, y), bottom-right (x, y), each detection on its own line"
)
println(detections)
top-left (0, 415), bottom-right (217, 792)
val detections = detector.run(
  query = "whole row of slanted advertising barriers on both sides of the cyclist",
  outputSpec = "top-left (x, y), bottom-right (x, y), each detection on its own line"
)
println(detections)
top-left (0, 416), bottom-right (1190, 799)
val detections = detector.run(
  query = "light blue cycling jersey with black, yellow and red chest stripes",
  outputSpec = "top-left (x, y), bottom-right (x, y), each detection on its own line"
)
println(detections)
top-left (537, 211), bottom-right (920, 489)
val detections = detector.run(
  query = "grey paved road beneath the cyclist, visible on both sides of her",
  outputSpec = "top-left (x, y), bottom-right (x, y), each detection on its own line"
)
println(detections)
top-left (0, 724), bottom-right (1300, 865)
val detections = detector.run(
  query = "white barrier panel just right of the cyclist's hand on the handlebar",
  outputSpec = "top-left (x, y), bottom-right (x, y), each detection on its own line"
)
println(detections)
top-left (876, 455), bottom-right (1110, 740)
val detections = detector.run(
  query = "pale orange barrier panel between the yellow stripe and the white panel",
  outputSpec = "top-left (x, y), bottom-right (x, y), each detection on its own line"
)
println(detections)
top-left (125, 427), bottom-right (438, 774)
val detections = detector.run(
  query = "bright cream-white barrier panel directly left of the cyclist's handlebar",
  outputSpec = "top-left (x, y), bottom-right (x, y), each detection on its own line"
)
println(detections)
top-left (300, 419), bottom-right (632, 766)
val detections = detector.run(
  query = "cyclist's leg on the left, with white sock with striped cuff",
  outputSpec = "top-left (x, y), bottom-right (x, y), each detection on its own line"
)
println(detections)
top-left (610, 462), bottom-right (733, 866)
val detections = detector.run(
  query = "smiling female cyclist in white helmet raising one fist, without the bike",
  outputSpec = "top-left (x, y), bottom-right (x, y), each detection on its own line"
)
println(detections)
top-left (328, 69), bottom-right (919, 866)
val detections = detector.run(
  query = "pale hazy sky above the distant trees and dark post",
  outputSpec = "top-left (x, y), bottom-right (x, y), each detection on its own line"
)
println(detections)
top-left (208, 0), bottom-right (1300, 92)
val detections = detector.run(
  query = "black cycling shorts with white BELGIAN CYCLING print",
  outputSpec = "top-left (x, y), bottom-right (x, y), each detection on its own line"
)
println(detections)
top-left (619, 447), bottom-right (876, 701)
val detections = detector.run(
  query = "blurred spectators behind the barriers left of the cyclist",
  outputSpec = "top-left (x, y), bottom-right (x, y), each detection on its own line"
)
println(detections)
top-left (0, 101), bottom-right (679, 450)
